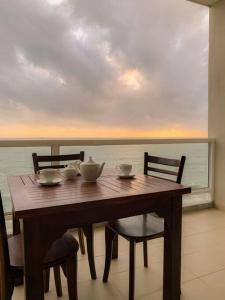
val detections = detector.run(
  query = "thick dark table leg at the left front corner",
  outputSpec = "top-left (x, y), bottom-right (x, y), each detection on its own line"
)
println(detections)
top-left (23, 219), bottom-right (44, 300)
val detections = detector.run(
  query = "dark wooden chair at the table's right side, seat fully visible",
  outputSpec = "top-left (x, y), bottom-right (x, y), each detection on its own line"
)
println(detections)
top-left (103, 152), bottom-right (186, 300)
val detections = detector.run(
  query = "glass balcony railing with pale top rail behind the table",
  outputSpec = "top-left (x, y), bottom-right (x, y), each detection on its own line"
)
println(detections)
top-left (0, 138), bottom-right (215, 211)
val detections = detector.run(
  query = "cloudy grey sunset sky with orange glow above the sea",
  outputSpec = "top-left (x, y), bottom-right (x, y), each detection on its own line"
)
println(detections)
top-left (0, 0), bottom-right (209, 138)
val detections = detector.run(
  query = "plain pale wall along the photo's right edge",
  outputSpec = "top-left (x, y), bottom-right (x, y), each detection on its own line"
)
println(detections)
top-left (208, 0), bottom-right (225, 210)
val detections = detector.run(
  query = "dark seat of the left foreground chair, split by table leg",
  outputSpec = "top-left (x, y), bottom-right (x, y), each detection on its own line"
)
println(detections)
top-left (8, 233), bottom-right (79, 268)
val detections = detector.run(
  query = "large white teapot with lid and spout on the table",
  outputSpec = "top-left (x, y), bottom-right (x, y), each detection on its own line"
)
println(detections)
top-left (79, 156), bottom-right (105, 182)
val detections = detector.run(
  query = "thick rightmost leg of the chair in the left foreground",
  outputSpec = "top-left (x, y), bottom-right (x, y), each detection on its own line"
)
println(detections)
top-left (66, 254), bottom-right (78, 300)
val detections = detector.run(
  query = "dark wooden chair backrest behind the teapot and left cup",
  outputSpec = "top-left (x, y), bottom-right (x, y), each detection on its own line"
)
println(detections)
top-left (32, 151), bottom-right (84, 173)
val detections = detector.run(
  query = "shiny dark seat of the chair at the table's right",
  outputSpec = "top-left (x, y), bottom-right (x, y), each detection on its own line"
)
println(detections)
top-left (107, 214), bottom-right (164, 241)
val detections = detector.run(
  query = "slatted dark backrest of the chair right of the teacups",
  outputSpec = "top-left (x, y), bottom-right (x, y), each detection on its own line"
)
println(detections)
top-left (144, 152), bottom-right (186, 183)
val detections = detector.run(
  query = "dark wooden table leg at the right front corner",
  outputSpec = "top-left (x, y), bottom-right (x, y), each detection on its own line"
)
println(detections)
top-left (163, 196), bottom-right (182, 300)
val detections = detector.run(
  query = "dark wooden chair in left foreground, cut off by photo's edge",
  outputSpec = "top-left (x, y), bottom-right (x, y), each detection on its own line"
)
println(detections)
top-left (0, 194), bottom-right (79, 300)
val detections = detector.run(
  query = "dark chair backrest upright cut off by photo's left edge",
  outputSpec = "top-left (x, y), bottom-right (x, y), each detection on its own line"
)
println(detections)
top-left (0, 194), bottom-right (11, 299)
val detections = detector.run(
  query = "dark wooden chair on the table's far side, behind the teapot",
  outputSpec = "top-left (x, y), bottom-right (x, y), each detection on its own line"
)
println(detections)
top-left (32, 151), bottom-right (97, 279)
